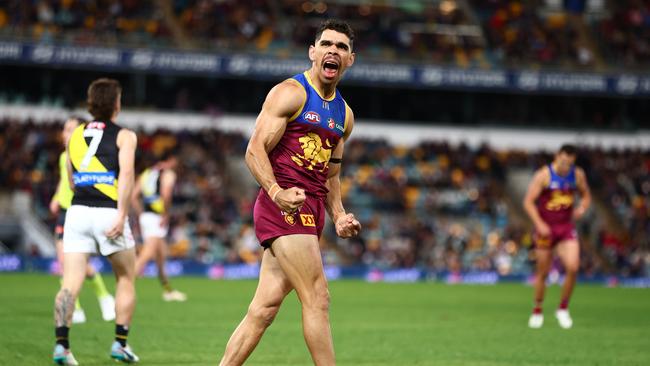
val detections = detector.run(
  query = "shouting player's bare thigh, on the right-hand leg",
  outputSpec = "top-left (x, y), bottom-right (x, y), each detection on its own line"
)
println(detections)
top-left (271, 234), bottom-right (327, 303)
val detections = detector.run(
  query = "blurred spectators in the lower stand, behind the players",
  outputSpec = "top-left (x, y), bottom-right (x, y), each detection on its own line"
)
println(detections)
top-left (0, 118), bottom-right (650, 276)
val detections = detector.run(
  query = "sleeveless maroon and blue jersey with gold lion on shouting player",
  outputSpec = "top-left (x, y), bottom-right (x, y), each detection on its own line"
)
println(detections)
top-left (269, 72), bottom-right (349, 198)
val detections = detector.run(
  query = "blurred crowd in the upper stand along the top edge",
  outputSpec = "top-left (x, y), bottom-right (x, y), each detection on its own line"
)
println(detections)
top-left (0, 0), bottom-right (650, 69)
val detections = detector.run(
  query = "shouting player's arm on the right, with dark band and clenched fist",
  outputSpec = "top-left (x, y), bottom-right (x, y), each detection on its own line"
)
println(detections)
top-left (325, 106), bottom-right (361, 238)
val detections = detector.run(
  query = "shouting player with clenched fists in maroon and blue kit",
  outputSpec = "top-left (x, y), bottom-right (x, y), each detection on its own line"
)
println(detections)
top-left (221, 20), bottom-right (361, 365)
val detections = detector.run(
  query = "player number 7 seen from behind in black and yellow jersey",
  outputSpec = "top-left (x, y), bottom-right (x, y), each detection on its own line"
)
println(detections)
top-left (53, 79), bottom-right (139, 365)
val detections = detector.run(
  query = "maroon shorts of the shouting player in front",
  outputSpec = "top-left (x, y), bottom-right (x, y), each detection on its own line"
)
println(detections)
top-left (253, 189), bottom-right (325, 248)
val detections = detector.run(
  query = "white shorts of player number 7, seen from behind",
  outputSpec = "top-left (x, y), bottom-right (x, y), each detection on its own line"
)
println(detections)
top-left (63, 205), bottom-right (135, 256)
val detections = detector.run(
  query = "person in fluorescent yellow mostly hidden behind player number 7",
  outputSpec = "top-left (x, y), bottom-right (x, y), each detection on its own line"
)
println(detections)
top-left (50, 118), bottom-right (115, 323)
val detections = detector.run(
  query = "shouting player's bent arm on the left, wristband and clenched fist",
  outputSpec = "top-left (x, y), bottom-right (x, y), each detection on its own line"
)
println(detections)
top-left (246, 81), bottom-right (306, 212)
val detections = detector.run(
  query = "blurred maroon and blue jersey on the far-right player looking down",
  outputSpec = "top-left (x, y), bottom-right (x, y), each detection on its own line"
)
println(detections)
top-left (536, 164), bottom-right (577, 226)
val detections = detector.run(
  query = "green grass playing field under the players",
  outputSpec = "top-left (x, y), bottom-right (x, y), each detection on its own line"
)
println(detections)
top-left (0, 274), bottom-right (650, 366)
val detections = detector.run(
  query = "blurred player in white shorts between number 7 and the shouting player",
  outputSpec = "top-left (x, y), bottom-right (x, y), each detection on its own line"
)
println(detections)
top-left (133, 151), bottom-right (187, 301)
